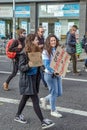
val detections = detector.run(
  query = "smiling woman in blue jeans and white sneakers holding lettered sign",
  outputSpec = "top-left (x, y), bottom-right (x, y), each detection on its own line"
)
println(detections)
top-left (40, 34), bottom-right (62, 118)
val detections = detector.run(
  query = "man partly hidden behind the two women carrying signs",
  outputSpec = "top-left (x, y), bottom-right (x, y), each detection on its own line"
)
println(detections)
top-left (37, 26), bottom-right (48, 88)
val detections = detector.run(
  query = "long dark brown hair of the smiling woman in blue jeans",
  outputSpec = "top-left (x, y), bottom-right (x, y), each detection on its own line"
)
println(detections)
top-left (44, 34), bottom-right (59, 56)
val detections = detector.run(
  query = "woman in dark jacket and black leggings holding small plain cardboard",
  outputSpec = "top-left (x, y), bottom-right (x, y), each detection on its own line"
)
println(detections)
top-left (14, 34), bottom-right (54, 129)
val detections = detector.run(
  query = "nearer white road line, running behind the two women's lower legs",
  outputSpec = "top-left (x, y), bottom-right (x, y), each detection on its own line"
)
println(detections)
top-left (0, 97), bottom-right (87, 116)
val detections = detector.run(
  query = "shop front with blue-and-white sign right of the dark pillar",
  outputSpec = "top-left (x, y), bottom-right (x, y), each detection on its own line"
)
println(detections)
top-left (38, 3), bottom-right (80, 40)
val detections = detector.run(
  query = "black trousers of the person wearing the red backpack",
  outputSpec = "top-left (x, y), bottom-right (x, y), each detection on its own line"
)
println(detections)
top-left (6, 59), bottom-right (18, 84)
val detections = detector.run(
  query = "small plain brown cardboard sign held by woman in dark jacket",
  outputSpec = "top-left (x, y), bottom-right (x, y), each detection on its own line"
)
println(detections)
top-left (28, 52), bottom-right (42, 67)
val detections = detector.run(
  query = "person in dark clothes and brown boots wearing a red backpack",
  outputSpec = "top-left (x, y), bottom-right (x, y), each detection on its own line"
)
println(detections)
top-left (3, 29), bottom-right (26, 91)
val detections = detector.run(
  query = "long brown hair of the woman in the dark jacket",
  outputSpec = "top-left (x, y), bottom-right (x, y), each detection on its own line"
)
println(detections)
top-left (25, 34), bottom-right (41, 53)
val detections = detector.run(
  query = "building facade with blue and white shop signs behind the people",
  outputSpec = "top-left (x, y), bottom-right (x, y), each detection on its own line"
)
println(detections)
top-left (0, 0), bottom-right (87, 40)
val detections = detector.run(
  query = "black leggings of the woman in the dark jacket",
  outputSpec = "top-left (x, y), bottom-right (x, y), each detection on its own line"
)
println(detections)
top-left (17, 95), bottom-right (43, 122)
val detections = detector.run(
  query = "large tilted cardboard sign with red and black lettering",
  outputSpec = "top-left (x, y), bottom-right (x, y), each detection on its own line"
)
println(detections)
top-left (50, 47), bottom-right (71, 77)
